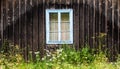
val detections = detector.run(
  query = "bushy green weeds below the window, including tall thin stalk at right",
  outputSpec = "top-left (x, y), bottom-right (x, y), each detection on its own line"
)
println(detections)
top-left (42, 33), bottom-right (107, 64)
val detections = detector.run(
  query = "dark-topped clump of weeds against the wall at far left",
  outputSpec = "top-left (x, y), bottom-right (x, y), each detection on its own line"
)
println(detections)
top-left (0, 40), bottom-right (23, 65)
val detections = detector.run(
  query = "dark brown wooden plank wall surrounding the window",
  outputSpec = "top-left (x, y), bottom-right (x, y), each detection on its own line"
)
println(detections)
top-left (0, 0), bottom-right (120, 59)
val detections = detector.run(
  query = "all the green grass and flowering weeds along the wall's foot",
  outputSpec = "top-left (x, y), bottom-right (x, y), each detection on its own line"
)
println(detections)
top-left (0, 46), bottom-right (120, 69)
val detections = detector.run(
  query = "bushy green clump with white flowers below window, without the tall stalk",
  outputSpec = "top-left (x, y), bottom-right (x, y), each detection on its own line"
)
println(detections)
top-left (42, 45), bottom-right (95, 64)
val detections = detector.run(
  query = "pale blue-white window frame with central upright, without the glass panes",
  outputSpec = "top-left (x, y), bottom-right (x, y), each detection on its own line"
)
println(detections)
top-left (46, 9), bottom-right (73, 44)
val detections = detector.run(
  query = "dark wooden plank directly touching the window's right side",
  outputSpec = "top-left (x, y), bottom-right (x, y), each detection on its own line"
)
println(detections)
top-left (73, 0), bottom-right (80, 50)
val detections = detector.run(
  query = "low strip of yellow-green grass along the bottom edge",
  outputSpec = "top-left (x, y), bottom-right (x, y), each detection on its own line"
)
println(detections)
top-left (0, 58), bottom-right (120, 69)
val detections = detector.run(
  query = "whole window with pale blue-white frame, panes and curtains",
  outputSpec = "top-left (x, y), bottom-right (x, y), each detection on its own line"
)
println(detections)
top-left (46, 9), bottom-right (73, 44)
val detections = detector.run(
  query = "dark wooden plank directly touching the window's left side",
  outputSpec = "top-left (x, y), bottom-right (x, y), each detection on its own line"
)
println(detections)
top-left (38, 0), bottom-right (46, 57)
